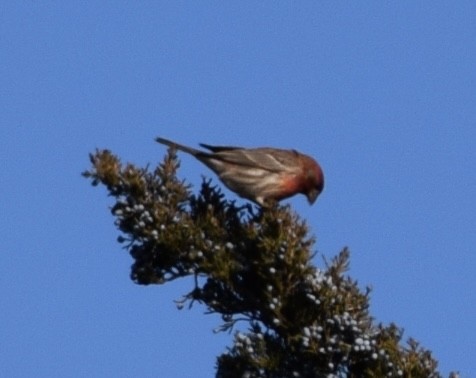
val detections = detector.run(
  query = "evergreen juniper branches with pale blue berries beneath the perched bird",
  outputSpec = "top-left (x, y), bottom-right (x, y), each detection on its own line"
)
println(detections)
top-left (83, 149), bottom-right (456, 378)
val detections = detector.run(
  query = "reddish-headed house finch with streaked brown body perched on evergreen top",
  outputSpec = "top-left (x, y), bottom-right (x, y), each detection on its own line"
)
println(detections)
top-left (156, 138), bottom-right (324, 207)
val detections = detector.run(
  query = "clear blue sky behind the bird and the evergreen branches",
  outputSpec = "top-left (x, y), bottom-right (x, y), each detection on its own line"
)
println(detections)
top-left (0, 1), bottom-right (476, 377)
